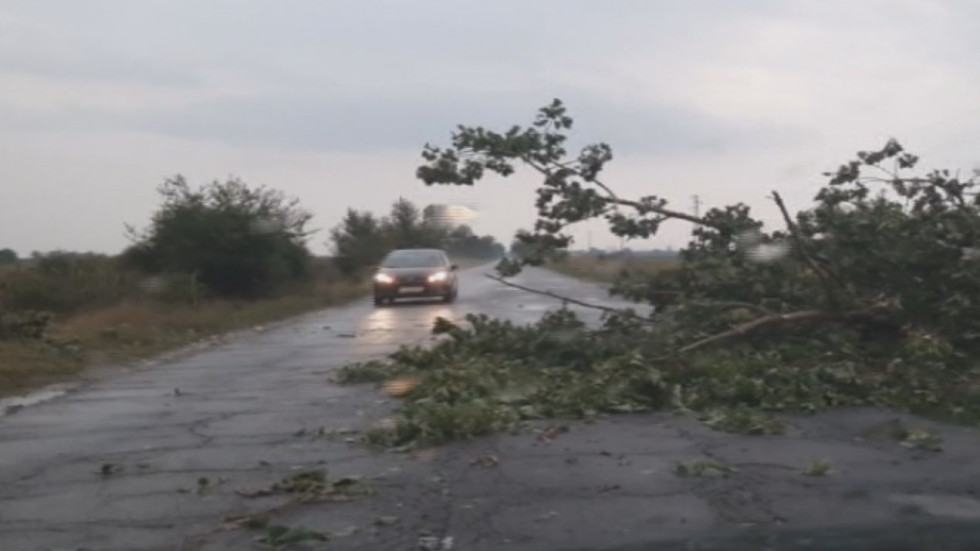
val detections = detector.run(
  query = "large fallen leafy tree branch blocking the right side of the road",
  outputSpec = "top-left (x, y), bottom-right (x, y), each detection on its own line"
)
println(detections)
top-left (334, 100), bottom-right (980, 444)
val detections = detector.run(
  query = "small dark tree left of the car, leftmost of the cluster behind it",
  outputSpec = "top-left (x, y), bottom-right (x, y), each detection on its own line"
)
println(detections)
top-left (330, 209), bottom-right (388, 276)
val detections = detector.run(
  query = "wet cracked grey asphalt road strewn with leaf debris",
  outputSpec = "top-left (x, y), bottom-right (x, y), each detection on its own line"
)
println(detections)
top-left (0, 269), bottom-right (980, 551)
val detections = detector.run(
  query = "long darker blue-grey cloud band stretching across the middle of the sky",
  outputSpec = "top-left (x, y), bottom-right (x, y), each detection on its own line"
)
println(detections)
top-left (129, 91), bottom-right (820, 156)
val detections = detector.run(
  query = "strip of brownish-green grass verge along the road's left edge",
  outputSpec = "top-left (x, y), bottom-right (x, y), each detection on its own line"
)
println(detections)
top-left (0, 278), bottom-right (370, 395)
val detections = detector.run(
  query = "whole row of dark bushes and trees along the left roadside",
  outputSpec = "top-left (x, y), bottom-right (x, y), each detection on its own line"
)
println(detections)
top-left (0, 176), bottom-right (503, 336)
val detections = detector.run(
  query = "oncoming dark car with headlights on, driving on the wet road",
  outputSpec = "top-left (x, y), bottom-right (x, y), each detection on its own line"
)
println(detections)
top-left (374, 249), bottom-right (459, 305)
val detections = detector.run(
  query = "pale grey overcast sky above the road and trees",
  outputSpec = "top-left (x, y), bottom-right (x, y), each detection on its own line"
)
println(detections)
top-left (0, 0), bottom-right (980, 254)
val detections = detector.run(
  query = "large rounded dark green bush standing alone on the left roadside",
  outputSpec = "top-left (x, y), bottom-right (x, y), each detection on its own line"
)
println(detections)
top-left (125, 175), bottom-right (311, 297)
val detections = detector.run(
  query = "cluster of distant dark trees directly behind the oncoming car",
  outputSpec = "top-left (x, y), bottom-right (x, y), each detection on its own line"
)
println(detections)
top-left (330, 198), bottom-right (505, 276)
